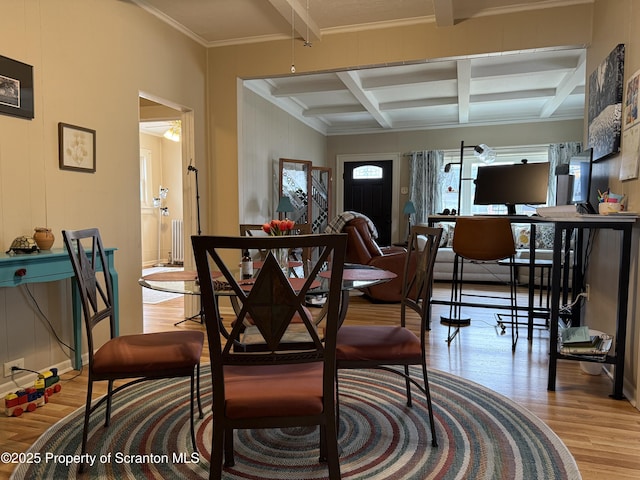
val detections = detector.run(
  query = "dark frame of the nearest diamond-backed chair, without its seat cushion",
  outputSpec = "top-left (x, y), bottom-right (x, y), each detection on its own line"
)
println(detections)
top-left (192, 234), bottom-right (346, 480)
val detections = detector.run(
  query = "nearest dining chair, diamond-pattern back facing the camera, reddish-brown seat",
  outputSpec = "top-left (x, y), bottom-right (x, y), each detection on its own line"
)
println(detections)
top-left (191, 234), bottom-right (346, 480)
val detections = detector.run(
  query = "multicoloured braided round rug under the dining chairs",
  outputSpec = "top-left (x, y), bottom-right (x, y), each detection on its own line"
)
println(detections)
top-left (11, 366), bottom-right (581, 480)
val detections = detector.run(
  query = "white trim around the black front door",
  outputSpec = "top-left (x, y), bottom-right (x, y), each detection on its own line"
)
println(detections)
top-left (334, 153), bottom-right (402, 242)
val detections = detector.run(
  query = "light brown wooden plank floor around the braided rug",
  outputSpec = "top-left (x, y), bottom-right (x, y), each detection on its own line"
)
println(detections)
top-left (0, 284), bottom-right (640, 480)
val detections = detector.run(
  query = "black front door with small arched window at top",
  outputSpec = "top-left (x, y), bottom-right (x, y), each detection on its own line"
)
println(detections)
top-left (343, 160), bottom-right (393, 247)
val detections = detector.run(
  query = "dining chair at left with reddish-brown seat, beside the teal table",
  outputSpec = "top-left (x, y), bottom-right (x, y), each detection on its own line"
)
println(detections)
top-left (62, 228), bottom-right (204, 471)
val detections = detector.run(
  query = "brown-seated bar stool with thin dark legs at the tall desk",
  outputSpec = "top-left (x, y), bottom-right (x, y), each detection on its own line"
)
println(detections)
top-left (441, 217), bottom-right (518, 351)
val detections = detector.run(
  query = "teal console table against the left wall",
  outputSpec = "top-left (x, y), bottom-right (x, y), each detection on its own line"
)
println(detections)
top-left (0, 248), bottom-right (119, 369)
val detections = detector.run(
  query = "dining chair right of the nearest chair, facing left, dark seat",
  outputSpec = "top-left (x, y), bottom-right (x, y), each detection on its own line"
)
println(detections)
top-left (336, 226), bottom-right (442, 447)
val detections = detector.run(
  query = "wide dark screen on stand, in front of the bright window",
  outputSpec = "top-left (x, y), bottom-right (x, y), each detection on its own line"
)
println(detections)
top-left (473, 161), bottom-right (549, 215)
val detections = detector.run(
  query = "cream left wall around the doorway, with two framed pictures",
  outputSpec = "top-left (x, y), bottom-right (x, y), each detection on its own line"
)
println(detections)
top-left (0, 0), bottom-right (206, 391)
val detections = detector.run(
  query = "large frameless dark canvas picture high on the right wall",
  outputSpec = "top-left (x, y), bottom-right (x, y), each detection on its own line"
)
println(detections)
top-left (587, 44), bottom-right (624, 162)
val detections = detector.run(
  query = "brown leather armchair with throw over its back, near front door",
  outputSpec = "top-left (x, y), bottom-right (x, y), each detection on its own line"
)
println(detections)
top-left (342, 217), bottom-right (415, 302)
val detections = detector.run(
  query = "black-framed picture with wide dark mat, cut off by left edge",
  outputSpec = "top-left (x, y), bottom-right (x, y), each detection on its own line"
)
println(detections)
top-left (0, 55), bottom-right (33, 120)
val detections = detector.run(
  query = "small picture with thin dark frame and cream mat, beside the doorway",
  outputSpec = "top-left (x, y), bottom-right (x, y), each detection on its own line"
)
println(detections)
top-left (58, 123), bottom-right (96, 173)
